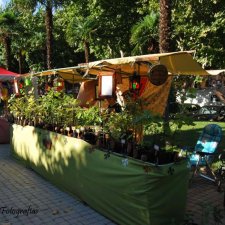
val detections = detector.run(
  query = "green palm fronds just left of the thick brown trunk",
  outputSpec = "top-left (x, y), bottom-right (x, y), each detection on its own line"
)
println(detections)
top-left (130, 12), bottom-right (159, 54)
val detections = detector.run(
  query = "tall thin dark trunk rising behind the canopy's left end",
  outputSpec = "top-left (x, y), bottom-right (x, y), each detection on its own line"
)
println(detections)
top-left (45, 1), bottom-right (53, 69)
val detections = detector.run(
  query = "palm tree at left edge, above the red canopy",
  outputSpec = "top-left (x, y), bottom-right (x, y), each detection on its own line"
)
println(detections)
top-left (0, 11), bottom-right (16, 70)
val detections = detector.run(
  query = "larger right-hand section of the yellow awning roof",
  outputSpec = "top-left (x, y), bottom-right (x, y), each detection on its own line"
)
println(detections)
top-left (80, 51), bottom-right (210, 76)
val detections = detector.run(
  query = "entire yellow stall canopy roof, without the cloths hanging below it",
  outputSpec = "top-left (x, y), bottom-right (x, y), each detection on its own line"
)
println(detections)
top-left (20, 51), bottom-right (215, 83)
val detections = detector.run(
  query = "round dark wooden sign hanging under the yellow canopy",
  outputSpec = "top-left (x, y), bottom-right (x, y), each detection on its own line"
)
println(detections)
top-left (149, 64), bottom-right (168, 86)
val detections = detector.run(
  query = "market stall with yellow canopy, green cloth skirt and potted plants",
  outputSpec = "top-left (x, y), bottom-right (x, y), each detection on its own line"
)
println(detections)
top-left (11, 52), bottom-right (214, 225)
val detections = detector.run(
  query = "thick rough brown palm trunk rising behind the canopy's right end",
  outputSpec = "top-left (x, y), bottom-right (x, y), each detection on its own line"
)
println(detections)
top-left (159, 0), bottom-right (171, 53)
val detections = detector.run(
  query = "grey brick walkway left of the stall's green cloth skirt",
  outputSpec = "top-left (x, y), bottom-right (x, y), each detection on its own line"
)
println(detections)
top-left (0, 144), bottom-right (115, 225)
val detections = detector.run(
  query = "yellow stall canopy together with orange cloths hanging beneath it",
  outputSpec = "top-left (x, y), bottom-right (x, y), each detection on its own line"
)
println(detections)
top-left (18, 51), bottom-right (221, 115)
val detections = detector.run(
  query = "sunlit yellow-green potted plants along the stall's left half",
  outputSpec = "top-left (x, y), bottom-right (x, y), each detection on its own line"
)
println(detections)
top-left (8, 89), bottom-right (102, 127)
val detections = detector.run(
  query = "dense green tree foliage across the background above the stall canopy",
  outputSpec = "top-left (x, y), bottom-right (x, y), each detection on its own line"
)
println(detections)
top-left (0, 0), bottom-right (225, 73)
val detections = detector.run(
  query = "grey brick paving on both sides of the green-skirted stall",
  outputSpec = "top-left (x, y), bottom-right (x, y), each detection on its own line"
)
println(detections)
top-left (0, 145), bottom-right (225, 225)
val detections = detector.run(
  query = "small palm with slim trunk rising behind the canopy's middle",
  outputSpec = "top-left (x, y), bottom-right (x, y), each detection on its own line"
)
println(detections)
top-left (66, 16), bottom-right (97, 63)
